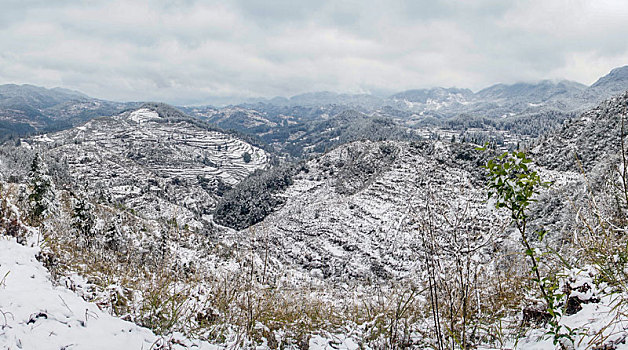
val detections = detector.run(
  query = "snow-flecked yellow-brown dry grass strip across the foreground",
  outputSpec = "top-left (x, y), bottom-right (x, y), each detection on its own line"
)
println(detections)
top-left (6, 185), bottom-right (556, 349)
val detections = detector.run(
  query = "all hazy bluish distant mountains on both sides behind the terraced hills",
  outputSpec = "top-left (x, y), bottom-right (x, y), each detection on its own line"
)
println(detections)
top-left (0, 67), bottom-right (628, 157)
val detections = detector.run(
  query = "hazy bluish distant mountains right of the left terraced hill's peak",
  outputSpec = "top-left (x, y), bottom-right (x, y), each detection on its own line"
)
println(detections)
top-left (175, 67), bottom-right (628, 158)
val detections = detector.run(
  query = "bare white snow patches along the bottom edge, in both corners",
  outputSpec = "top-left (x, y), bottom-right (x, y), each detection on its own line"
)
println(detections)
top-left (0, 230), bottom-right (628, 350)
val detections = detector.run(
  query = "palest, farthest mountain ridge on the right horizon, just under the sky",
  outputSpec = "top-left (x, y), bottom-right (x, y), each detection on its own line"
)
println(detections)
top-left (242, 66), bottom-right (628, 116)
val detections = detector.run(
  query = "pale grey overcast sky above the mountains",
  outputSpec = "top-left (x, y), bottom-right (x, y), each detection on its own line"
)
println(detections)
top-left (0, 0), bottom-right (628, 104)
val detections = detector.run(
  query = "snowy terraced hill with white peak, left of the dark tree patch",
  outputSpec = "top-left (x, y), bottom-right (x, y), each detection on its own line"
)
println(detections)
top-left (28, 108), bottom-right (269, 228)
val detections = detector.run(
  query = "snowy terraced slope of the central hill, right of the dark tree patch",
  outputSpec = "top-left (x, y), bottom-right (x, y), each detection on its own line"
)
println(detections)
top-left (236, 141), bottom-right (500, 281)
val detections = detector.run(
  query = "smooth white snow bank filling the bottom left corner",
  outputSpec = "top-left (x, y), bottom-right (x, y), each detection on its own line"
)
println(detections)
top-left (0, 236), bottom-right (217, 350)
